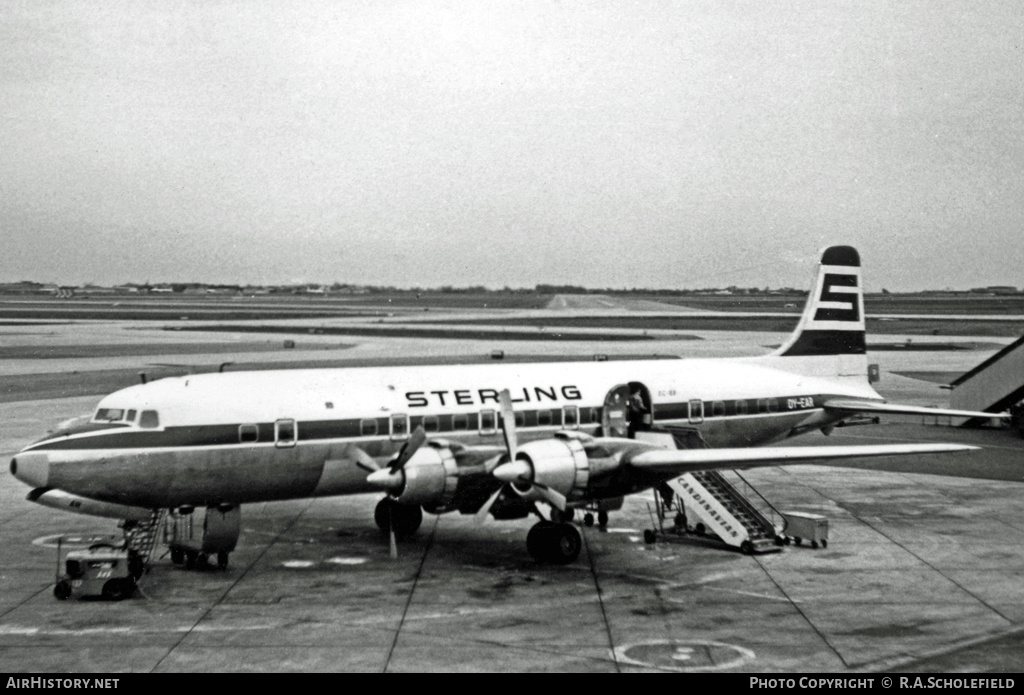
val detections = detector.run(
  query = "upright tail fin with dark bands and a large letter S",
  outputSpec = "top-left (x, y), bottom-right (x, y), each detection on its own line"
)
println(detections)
top-left (763, 246), bottom-right (867, 382)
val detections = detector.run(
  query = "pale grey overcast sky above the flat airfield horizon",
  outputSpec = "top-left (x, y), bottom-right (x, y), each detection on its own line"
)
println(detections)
top-left (0, 0), bottom-right (1024, 291)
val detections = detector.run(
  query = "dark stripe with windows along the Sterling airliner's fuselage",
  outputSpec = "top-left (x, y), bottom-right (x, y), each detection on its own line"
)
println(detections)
top-left (30, 395), bottom-right (828, 451)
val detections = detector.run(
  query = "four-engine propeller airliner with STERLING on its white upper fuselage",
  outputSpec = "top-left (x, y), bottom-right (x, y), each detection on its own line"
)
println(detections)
top-left (10, 247), bottom-right (998, 563)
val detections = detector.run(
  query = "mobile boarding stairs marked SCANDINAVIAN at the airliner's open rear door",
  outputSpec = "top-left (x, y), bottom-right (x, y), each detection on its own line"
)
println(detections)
top-left (644, 428), bottom-right (785, 554)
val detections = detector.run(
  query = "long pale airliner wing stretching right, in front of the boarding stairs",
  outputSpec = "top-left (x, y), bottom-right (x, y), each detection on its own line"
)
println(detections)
top-left (624, 444), bottom-right (979, 475)
